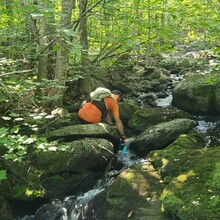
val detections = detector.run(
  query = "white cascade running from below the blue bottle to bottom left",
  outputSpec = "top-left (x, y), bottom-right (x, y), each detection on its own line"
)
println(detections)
top-left (16, 144), bottom-right (148, 220)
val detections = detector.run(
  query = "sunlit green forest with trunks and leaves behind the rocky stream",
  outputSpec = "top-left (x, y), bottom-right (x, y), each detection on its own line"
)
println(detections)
top-left (0, 0), bottom-right (220, 179)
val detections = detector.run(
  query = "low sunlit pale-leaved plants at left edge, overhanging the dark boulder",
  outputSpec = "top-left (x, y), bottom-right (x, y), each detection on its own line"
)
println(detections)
top-left (0, 114), bottom-right (65, 162)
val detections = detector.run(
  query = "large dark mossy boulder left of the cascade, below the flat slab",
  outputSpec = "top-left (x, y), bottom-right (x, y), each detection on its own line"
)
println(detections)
top-left (0, 138), bottom-right (114, 201)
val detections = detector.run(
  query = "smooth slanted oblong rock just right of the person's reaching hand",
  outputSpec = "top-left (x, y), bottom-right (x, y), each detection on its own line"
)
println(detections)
top-left (130, 119), bottom-right (197, 156)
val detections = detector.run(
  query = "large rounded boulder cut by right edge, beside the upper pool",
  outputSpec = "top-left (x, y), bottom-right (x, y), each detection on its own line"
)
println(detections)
top-left (173, 74), bottom-right (220, 114)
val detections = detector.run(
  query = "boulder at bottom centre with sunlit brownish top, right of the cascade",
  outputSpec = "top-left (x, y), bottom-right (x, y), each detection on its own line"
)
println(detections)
top-left (89, 164), bottom-right (169, 220)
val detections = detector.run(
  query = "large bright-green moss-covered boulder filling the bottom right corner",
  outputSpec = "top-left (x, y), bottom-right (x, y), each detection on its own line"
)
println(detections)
top-left (148, 131), bottom-right (220, 220)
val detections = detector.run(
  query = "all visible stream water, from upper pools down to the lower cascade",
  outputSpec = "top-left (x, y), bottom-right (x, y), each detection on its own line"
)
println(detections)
top-left (16, 95), bottom-right (220, 220)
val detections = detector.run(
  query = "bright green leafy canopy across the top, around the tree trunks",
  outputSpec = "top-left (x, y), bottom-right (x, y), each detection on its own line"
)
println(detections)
top-left (0, 0), bottom-right (220, 68)
